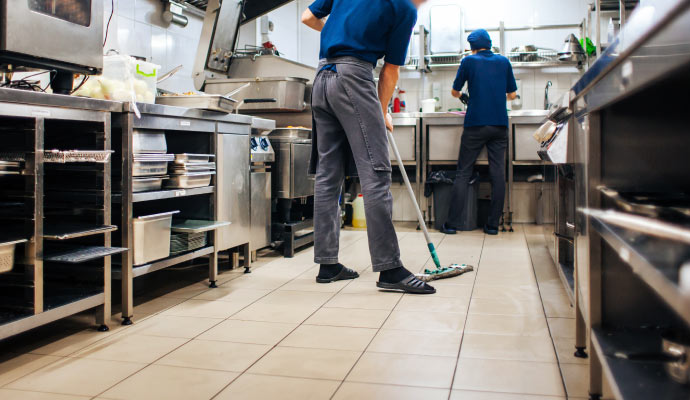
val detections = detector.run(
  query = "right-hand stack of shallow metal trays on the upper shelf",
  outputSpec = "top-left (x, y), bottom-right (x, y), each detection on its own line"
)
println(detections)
top-left (165, 153), bottom-right (216, 189)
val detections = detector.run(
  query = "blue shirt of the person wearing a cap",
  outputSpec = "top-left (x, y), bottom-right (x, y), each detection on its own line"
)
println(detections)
top-left (453, 50), bottom-right (517, 127)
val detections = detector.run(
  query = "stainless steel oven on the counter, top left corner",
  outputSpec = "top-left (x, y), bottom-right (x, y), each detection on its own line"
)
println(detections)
top-left (0, 0), bottom-right (103, 94)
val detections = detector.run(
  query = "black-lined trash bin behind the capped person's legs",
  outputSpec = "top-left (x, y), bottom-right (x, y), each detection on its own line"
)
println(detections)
top-left (424, 171), bottom-right (479, 231)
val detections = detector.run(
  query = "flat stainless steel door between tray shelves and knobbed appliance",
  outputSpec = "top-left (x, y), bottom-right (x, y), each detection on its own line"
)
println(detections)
top-left (216, 134), bottom-right (250, 251)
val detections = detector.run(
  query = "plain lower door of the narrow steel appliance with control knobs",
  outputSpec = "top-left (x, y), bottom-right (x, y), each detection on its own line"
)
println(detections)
top-left (249, 171), bottom-right (271, 251)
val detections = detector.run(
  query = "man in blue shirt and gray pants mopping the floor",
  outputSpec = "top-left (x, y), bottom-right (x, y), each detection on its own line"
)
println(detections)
top-left (302, 0), bottom-right (436, 294)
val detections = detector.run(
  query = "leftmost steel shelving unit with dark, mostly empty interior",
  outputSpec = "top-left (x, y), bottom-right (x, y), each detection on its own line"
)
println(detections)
top-left (0, 89), bottom-right (126, 339)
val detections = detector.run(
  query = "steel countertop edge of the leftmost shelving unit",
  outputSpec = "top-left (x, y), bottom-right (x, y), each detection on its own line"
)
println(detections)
top-left (0, 88), bottom-right (122, 112)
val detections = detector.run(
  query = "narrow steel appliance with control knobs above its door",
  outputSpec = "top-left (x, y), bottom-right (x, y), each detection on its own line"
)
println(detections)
top-left (249, 119), bottom-right (275, 251)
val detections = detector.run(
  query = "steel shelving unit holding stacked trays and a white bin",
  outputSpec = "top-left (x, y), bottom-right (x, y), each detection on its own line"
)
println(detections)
top-left (113, 103), bottom-right (252, 325)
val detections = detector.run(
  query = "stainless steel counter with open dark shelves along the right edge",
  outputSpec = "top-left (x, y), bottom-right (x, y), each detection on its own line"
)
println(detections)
top-left (571, 0), bottom-right (690, 399)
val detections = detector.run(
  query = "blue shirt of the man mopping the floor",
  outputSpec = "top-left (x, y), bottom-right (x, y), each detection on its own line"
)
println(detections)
top-left (309, 0), bottom-right (417, 65)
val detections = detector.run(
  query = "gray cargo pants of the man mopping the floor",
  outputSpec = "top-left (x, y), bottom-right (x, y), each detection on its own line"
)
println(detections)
top-left (312, 57), bottom-right (402, 272)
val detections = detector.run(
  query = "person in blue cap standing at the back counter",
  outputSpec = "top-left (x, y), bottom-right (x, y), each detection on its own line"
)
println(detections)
top-left (443, 29), bottom-right (517, 235)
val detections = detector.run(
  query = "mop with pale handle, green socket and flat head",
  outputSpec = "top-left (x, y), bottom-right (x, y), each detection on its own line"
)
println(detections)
top-left (386, 129), bottom-right (474, 282)
